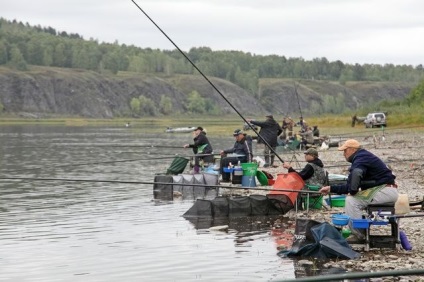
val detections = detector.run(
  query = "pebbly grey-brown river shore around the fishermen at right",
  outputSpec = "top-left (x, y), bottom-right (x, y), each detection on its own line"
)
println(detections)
top-left (220, 132), bottom-right (424, 281)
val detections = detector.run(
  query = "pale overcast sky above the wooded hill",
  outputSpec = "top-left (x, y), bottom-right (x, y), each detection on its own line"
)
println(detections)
top-left (0, 0), bottom-right (424, 66)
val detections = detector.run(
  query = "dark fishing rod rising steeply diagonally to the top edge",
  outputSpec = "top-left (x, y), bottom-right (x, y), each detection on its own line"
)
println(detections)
top-left (131, 0), bottom-right (284, 163)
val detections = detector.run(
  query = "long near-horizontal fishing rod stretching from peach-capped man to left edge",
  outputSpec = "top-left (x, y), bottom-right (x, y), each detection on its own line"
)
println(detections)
top-left (0, 177), bottom-right (321, 194)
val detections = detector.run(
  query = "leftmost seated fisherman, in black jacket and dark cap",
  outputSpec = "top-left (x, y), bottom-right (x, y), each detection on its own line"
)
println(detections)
top-left (183, 126), bottom-right (213, 173)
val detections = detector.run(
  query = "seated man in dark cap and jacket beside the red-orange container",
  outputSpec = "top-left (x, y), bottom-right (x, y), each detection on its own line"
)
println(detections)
top-left (283, 148), bottom-right (327, 187)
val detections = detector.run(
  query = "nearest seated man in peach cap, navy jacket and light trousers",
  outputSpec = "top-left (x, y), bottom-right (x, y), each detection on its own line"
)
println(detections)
top-left (320, 139), bottom-right (398, 241)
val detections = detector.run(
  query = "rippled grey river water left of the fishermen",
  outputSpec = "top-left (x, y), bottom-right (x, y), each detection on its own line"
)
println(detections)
top-left (0, 125), bottom-right (295, 281)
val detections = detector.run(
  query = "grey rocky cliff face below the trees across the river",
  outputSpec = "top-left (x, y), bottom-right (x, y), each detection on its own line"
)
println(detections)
top-left (0, 68), bottom-right (414, 118)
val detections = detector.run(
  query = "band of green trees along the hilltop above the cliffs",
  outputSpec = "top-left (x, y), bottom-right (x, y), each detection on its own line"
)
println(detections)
top-left (0, 18), bottom-right (424, 95)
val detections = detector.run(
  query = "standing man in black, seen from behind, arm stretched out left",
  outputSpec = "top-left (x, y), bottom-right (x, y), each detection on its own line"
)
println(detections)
top-left (248, 114), bottom-right (283, 166)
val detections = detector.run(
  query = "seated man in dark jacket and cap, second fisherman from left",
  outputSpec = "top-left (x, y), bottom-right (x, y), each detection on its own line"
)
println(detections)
top-left (220, 129), bottom-right (253, 182)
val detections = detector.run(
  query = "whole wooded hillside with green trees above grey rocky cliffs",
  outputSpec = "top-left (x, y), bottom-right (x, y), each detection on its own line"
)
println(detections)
top-left (0, 18), bottom-right (424, 118)
